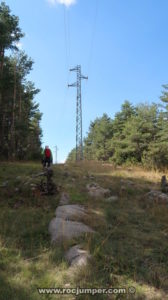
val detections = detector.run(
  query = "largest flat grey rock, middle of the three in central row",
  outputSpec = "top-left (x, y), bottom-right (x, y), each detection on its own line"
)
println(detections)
top-left (49, 217), bottom-right (94, 242)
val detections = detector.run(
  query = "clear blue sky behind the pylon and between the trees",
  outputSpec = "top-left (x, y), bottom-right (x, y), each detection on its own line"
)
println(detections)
top-left (5, 0), bottom-right (168, 162)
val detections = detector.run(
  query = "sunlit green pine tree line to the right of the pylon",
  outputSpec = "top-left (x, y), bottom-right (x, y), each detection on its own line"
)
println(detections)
top-left (67, 85), bottom-right (168, 169)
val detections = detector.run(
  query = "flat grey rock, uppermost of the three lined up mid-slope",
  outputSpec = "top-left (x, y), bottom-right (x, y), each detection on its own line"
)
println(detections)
top-left (55, 204), bottom-right (86, 221)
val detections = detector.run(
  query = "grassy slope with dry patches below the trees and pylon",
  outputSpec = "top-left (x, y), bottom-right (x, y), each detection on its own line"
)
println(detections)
top-left (0, 163), bottom-right (168, 300)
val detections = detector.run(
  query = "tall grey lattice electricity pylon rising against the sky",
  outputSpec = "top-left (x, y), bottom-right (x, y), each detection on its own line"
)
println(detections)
top-left (68, 65), bottom-right (88, 161)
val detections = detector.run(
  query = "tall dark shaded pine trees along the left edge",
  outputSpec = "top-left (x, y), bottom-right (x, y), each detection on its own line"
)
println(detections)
top-left (0, 2), bottom-right (42, 159)
